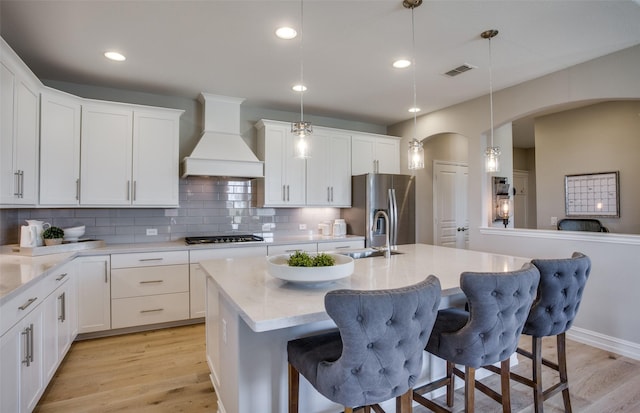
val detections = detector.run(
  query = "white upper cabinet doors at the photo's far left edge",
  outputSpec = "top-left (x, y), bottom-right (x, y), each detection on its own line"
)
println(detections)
top-left (0, 39), bottom-right (42, 205)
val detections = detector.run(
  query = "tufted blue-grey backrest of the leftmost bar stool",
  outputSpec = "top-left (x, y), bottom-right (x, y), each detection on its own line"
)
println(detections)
top-left (316, 275), bottom-right (441, 406)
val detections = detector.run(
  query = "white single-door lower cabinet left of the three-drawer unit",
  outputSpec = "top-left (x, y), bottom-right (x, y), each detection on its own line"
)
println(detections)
top-left (76, 255), bottom-right (111, 333)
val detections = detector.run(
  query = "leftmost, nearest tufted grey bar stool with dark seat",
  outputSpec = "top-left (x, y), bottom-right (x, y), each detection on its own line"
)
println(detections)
top-left (287, 275), bottom-right (441, 413)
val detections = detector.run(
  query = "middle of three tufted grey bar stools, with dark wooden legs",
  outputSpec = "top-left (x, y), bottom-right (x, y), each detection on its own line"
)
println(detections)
top-left (413, 263), bottom-right (540, 413)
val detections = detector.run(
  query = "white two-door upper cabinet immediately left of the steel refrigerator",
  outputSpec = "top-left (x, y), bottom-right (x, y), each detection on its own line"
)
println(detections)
top-left (307, 128), bottom-right (351, 207)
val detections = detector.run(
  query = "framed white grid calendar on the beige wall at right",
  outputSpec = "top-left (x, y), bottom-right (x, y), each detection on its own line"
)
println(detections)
top-left (564, 171), bottom-right (620, 217)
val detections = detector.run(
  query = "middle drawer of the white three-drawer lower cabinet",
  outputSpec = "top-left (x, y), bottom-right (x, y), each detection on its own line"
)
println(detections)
top-left (111, 264), bottom-right (189, 298)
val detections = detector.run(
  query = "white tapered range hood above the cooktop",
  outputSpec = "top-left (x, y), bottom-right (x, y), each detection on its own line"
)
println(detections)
top-left (182, 93), bottom-right (264, 178)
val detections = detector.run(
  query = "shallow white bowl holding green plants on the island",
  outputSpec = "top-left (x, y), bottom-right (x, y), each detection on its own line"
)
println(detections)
top-left (267, 254), bottom-right (354, 284)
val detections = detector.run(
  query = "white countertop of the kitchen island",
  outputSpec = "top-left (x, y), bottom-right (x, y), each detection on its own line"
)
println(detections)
top-left (200, 244), bottom-right (530, 332)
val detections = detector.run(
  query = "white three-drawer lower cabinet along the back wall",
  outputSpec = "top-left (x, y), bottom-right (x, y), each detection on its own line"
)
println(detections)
top-left (111, 251), bottom-right (189, 328)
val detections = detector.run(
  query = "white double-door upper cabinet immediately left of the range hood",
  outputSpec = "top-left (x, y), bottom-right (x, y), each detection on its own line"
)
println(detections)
top-left (80, 102), bottom-right (182, 207)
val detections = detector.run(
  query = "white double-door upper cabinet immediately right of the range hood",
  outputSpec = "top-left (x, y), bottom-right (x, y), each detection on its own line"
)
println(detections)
top-left (256, 120), bottom-right (305, 207)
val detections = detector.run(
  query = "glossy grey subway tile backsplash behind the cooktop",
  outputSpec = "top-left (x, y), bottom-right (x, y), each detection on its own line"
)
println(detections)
top-left (0, 177), bottom-right (340, 245)
